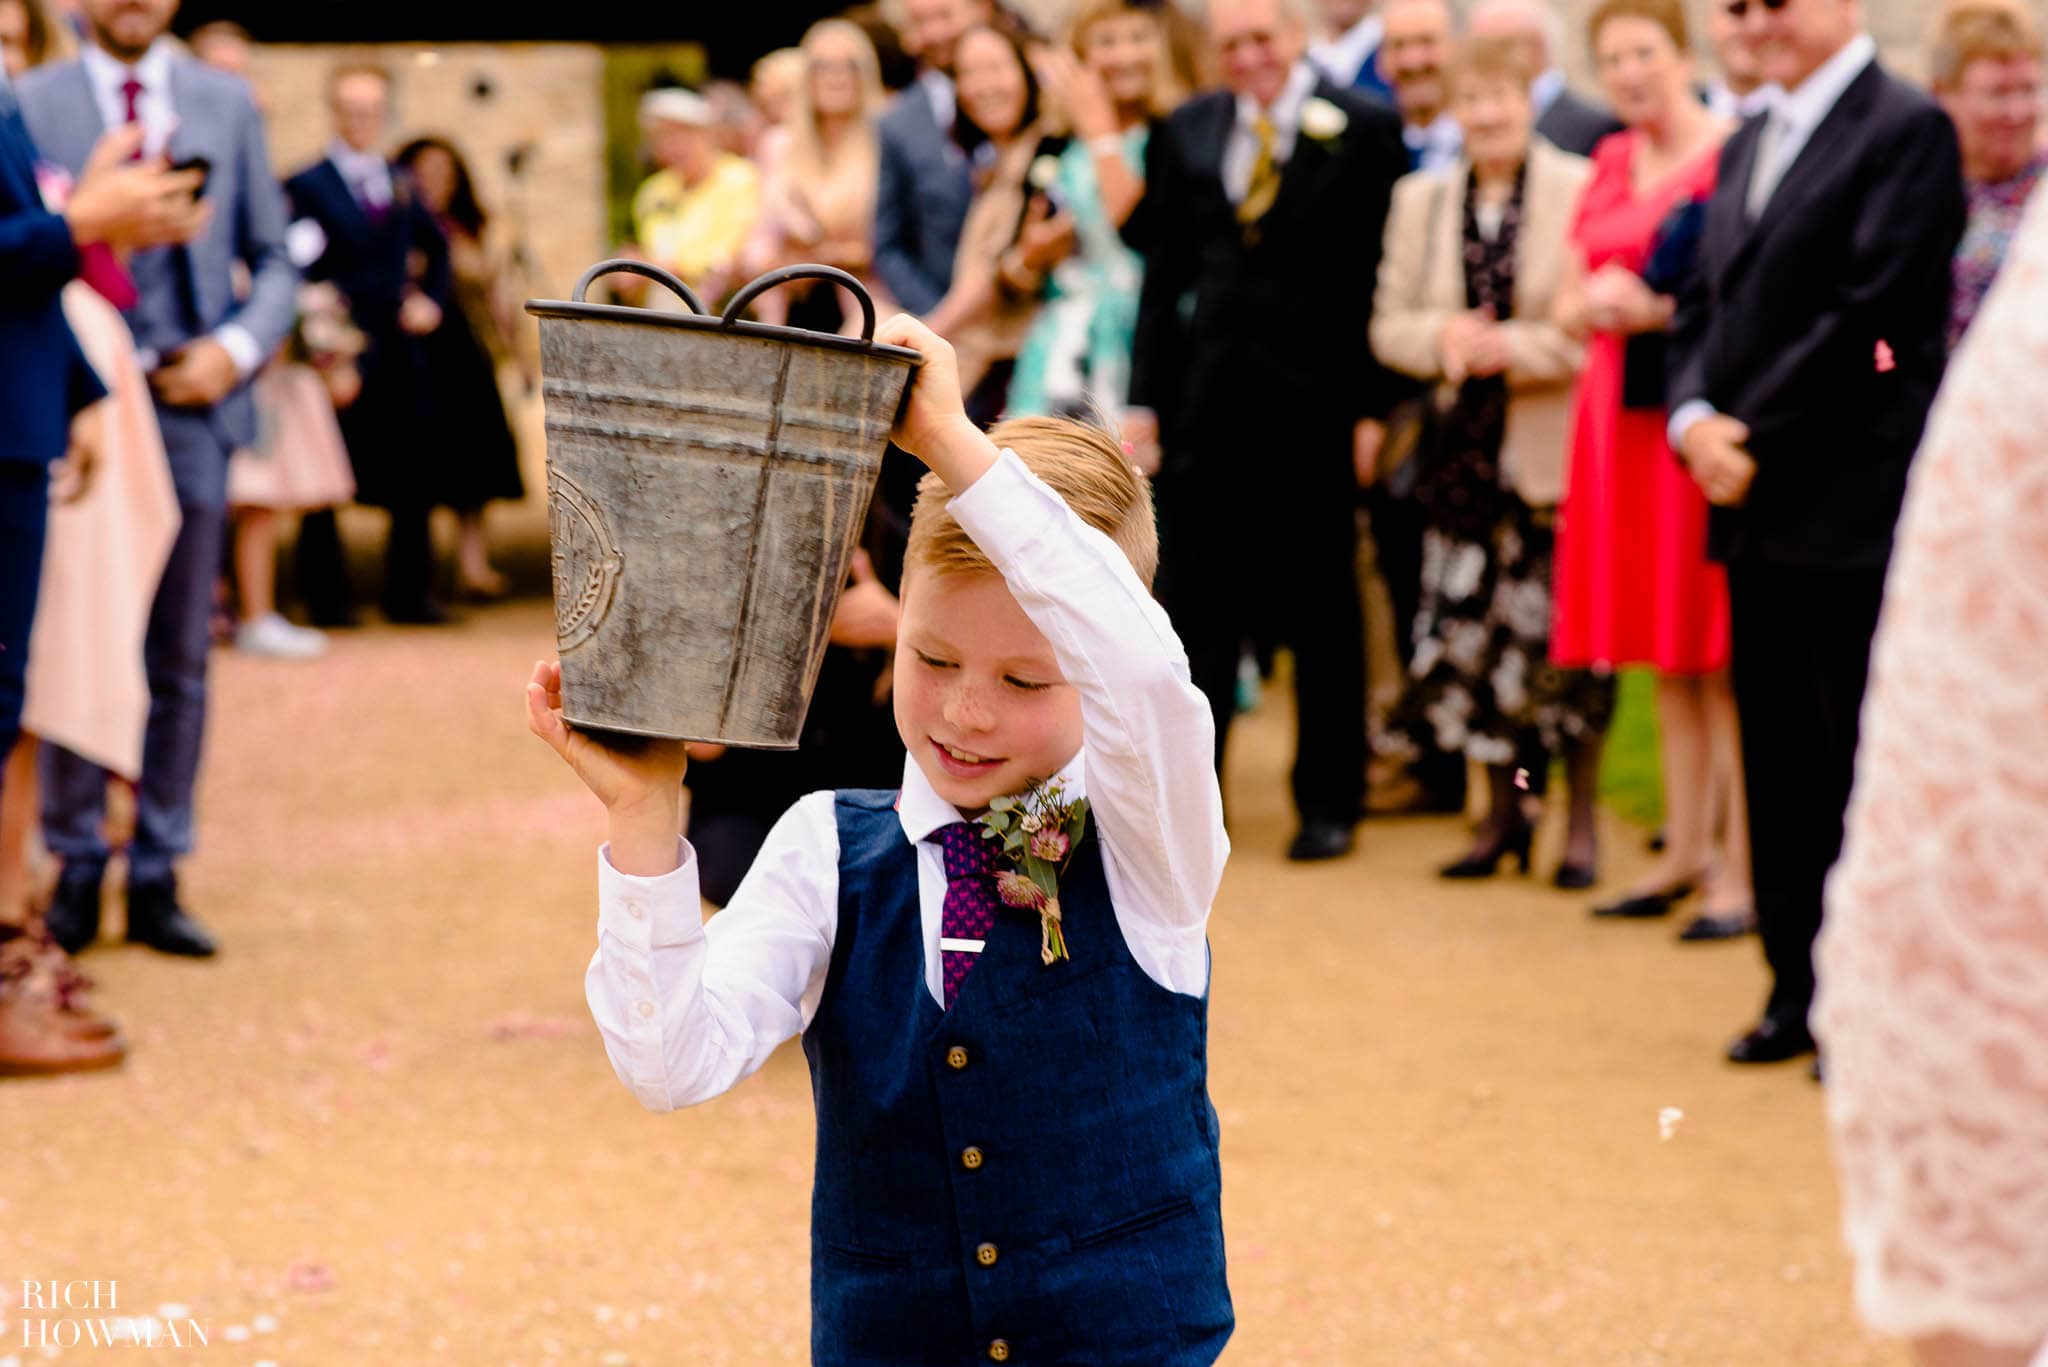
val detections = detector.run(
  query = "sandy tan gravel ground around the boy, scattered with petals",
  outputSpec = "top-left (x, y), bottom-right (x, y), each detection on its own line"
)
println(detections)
top-left (0, 603), bottom-right (1907, 1367)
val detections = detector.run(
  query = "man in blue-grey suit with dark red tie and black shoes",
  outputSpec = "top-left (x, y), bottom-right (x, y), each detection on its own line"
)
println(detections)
top-left (20, 0), bottom-right (299, 957)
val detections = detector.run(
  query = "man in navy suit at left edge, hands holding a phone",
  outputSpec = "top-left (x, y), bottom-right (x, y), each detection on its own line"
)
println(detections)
top-left (0, 83), bottom-right (203, 811)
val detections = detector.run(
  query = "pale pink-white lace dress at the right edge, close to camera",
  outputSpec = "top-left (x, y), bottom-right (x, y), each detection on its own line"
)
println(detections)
top-left (1815, 197), bottom-right (2048, 1363)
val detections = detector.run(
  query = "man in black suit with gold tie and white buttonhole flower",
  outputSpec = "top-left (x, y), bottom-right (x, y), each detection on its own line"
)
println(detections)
top-left (1126, 0), bottom-right (1407, 859)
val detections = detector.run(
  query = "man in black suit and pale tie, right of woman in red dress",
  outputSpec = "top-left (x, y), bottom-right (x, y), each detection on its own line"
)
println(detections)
top-left (1669, 0), bottom-right (1964, 1064)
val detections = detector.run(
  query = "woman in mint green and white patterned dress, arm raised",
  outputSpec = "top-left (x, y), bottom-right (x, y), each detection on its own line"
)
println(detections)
top-left (1006, 0), bottom-right (1182, 418)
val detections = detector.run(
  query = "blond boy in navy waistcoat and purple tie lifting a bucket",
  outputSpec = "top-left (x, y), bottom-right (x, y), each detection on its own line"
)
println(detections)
top-left (526, 318), bottom-right (1233, 1367)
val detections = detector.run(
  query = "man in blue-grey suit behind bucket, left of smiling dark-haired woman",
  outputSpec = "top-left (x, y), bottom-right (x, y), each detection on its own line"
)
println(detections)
top-left (874, 0), bottom-right (989, 314)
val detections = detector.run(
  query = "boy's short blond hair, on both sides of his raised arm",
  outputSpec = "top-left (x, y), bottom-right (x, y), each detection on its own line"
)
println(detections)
top-left (903, 418), bottom-right (1159, 588)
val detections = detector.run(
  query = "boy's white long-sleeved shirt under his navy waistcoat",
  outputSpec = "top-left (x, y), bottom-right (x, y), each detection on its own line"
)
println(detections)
top-left (584, 451), bottom-right (1231, 1111)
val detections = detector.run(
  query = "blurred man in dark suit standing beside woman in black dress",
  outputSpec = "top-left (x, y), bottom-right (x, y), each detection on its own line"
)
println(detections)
top-left (285, 66), bottom-right (453, 625)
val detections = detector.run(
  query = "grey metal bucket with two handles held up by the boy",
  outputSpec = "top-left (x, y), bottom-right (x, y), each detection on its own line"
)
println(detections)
top-left (526, 260), bottom-right (918, 750)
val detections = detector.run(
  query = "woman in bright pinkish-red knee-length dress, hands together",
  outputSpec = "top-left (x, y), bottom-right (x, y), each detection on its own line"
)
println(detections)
top-left (1550, 0), bottom-right (1753, 939)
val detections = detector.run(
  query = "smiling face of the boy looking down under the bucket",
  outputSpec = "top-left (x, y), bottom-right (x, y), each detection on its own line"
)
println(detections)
top-left (895, 566), bottom-right (1081, 816)
